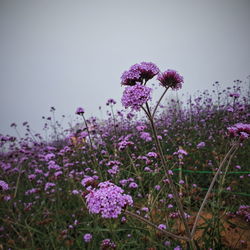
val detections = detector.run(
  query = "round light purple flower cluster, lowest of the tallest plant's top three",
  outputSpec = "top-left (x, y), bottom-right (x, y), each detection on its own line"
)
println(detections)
top-left (122, 84), bottom-right (152, 111)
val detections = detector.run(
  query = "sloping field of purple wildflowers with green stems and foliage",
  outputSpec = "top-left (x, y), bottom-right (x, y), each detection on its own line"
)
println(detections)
top-left (0, 62), bottom-right (250, 250)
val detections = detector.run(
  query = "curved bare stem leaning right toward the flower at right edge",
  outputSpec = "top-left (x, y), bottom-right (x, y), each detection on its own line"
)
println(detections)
top-left (191, 143), bottom-right (237, 237)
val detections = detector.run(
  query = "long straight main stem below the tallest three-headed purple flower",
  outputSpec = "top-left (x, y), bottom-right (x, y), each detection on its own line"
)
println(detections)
top-left (143, 103), bottom-right (194, 245)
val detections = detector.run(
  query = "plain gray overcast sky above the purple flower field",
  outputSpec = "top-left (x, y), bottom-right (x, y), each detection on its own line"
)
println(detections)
top-left (0, 0), bottom-right (250, 137)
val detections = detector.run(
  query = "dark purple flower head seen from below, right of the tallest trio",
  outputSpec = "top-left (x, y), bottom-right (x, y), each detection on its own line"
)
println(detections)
top-left (157, 69), bottom-right (183, 90)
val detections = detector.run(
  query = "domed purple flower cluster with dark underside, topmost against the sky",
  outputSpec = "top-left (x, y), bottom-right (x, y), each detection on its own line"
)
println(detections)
top-left (121, 62), bottom-right (159, 86)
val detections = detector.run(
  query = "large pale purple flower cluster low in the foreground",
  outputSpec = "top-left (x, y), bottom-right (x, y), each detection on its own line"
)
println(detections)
top-left (86, 181), bottom-right (133, 218)
